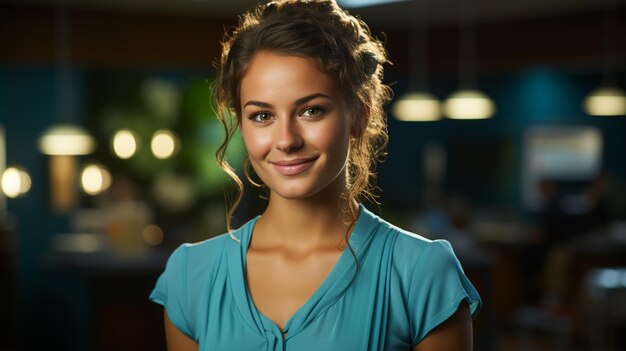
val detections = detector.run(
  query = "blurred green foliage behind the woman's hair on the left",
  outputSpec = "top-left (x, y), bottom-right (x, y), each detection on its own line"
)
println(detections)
top-left (90, 73), bottom-right (245, 210)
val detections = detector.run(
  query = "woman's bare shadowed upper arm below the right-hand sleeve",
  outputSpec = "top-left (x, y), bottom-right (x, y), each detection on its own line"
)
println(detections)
top-left (413, 303), bottom-right (473, 351)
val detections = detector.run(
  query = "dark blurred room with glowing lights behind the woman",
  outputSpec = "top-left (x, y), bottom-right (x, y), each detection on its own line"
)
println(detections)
top-left (0, 0), bottom-right (626, 350)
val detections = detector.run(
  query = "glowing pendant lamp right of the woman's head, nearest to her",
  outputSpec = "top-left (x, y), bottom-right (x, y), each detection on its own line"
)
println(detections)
top-left (392, 92), bottom-right (441, 121)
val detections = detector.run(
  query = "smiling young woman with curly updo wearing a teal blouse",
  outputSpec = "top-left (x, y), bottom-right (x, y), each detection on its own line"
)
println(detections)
top-left (150, 0), bottom-right (480, 351)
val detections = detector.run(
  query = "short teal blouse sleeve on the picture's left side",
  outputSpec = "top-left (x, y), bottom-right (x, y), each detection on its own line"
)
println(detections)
top-left (150, 245), bottom-right (196, 340)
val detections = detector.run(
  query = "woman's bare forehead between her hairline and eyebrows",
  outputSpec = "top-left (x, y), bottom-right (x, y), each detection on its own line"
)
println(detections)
top-left (240, 51), bottom-right (339, 106)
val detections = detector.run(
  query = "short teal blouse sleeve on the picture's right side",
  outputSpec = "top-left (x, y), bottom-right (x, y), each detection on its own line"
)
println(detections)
top-left (408, 240), bottom-right (481, 345)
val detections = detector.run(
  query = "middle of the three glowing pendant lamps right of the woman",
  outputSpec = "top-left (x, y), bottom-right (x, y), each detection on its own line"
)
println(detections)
top-left (444, 90), bottom-right (496, 119)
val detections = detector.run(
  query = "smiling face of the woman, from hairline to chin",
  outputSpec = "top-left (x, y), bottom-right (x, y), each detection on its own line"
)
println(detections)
top-left (240, 52), bottom-right (352, 199)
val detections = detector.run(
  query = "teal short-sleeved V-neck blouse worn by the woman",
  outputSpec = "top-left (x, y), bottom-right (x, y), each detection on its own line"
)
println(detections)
top-left (150, 206), bottom-right (481, 351)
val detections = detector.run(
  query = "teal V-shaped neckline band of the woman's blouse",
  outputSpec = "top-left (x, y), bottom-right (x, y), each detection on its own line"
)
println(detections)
top-left (228, 205), bottom-right (376, 340)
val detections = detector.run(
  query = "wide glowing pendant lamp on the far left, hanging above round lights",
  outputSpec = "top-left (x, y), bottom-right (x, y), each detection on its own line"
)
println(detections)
top-left (39, 124), bottom-right (96, 155)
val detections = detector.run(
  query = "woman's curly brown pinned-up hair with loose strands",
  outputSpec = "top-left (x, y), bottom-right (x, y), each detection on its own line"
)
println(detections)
top-left (215, 0), bottom-right (391, 244)
